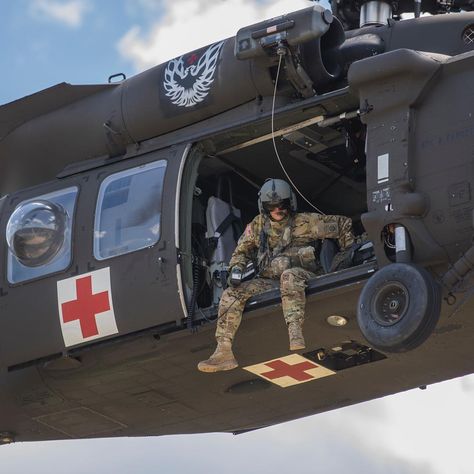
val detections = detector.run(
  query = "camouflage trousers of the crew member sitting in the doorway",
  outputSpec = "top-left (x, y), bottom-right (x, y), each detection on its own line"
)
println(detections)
top-left (216, 267), bottom-right (316, 340)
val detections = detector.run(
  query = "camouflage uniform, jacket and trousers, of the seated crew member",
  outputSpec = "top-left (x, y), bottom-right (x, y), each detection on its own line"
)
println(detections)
top-left (216, 213), bottom-right (354, 341)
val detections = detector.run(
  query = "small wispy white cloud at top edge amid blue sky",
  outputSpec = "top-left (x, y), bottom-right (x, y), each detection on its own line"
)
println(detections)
top-left (30, 0), bottom-right (91, 28)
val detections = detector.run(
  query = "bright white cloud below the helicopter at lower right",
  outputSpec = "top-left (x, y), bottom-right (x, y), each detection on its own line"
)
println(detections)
top-left (312, 375), bottom-right (474, 474)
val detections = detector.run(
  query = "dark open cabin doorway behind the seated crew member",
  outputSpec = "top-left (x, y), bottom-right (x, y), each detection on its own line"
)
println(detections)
top-left (179, 112), bottom-right (367, 321)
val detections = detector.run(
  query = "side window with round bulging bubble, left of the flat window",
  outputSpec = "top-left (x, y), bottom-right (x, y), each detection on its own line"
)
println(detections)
top-left (6, 187), bottom-right (78, 283)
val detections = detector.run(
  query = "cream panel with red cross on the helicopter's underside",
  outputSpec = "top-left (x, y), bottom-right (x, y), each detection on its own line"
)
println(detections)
top-left (244, 354), bottom-right (336, 387)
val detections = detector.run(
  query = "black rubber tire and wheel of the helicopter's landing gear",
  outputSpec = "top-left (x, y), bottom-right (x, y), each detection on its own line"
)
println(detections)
top-left (357, 263), bottom-right (441, 352)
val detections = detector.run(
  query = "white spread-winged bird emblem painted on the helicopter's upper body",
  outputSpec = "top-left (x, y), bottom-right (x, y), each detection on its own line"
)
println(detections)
top-left (163, 41), bottom-right (224, 107)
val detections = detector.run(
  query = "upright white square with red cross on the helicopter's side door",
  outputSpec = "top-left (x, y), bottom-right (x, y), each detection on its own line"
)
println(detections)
top-left (58, 268), bottom-right (118, 347)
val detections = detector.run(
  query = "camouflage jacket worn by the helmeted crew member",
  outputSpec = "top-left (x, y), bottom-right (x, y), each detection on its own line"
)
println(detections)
top-left (229, 213), bottom-right (354, 268)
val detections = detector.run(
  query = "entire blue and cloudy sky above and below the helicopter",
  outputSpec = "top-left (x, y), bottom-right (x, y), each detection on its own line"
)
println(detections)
top-left (0, 0), bottom-right (474, 474)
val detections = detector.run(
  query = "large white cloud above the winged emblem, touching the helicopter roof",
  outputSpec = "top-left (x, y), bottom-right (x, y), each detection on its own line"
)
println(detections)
top-left (118, 0), bottom-right (312, 71)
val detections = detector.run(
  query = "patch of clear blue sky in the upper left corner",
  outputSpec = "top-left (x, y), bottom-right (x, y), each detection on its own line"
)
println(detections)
top-left (0, 0), bottom-right (154, 104)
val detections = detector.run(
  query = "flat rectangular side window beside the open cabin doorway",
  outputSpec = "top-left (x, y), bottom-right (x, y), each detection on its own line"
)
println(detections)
top-left (94, 160), bottom-right (166, 260)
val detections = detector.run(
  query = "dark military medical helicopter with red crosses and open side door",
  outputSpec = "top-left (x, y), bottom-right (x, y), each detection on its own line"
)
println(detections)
top-left (0, 0), bottom-right (474, 443)
